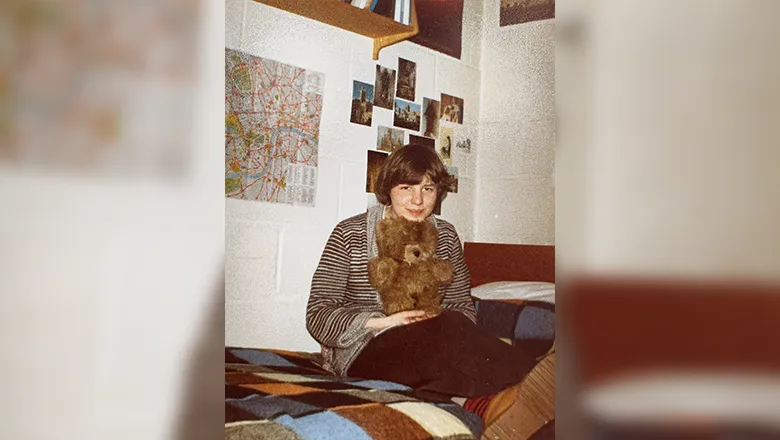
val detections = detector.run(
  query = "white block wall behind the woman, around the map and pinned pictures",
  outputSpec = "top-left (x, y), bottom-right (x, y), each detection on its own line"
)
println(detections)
top-left (225, 0), bottom-right (494, 351)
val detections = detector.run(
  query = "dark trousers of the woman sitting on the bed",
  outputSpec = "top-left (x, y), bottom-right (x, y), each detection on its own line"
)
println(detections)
top-left (347, 311), bottom-right (536, 398)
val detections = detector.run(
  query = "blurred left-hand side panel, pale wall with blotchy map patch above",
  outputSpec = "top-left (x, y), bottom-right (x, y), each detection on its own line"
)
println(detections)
top-left (0, 0), bottom-right (224, 440)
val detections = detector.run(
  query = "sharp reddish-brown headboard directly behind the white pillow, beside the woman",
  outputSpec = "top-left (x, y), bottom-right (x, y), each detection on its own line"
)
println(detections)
top-left (463, 242), bottom-right (555, 287)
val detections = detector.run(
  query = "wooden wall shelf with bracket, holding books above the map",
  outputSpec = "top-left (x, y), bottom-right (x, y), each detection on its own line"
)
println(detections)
top-left (255, 0), bottom-right (420, 60)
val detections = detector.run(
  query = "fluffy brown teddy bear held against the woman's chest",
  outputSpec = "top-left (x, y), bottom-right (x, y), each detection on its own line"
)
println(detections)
top-left (368, 217), bottom-right (452, 316)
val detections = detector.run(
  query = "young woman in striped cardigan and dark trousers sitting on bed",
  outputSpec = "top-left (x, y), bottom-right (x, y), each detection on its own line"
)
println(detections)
top-left (306, 144), bottom-right (536, 426)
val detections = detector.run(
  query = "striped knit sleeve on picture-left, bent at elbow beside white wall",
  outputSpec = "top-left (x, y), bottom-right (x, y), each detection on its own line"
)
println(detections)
top-left (306, 225), bottom-right (384, 348)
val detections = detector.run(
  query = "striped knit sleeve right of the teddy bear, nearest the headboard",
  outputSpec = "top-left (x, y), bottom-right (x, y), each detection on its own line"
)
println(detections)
top-left (439, 220), bottom-right (477, 323)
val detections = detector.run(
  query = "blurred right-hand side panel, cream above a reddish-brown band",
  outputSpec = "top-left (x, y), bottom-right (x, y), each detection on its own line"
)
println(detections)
top-left (556, 0), bottom-right (780, 439)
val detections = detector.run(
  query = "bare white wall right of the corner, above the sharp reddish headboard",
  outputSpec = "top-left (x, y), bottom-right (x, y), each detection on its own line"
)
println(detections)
top-left (474, 0), bottom-right (555, 244)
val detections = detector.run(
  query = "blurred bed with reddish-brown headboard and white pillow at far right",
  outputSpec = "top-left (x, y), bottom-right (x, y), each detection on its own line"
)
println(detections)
top-left (561, 275), bottom-right (780, 440)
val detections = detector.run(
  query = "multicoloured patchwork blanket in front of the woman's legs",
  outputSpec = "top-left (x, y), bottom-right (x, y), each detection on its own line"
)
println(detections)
top-left (225, 347), bottom-right (484, 440)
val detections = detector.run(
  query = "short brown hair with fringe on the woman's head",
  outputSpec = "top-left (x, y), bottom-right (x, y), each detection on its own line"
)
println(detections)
top-left (374, 144), bottom-right (455, 205)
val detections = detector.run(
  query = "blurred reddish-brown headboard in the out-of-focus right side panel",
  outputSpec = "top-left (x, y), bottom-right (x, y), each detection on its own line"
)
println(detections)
top-left (559, 276), bottom-right (780, 385)
